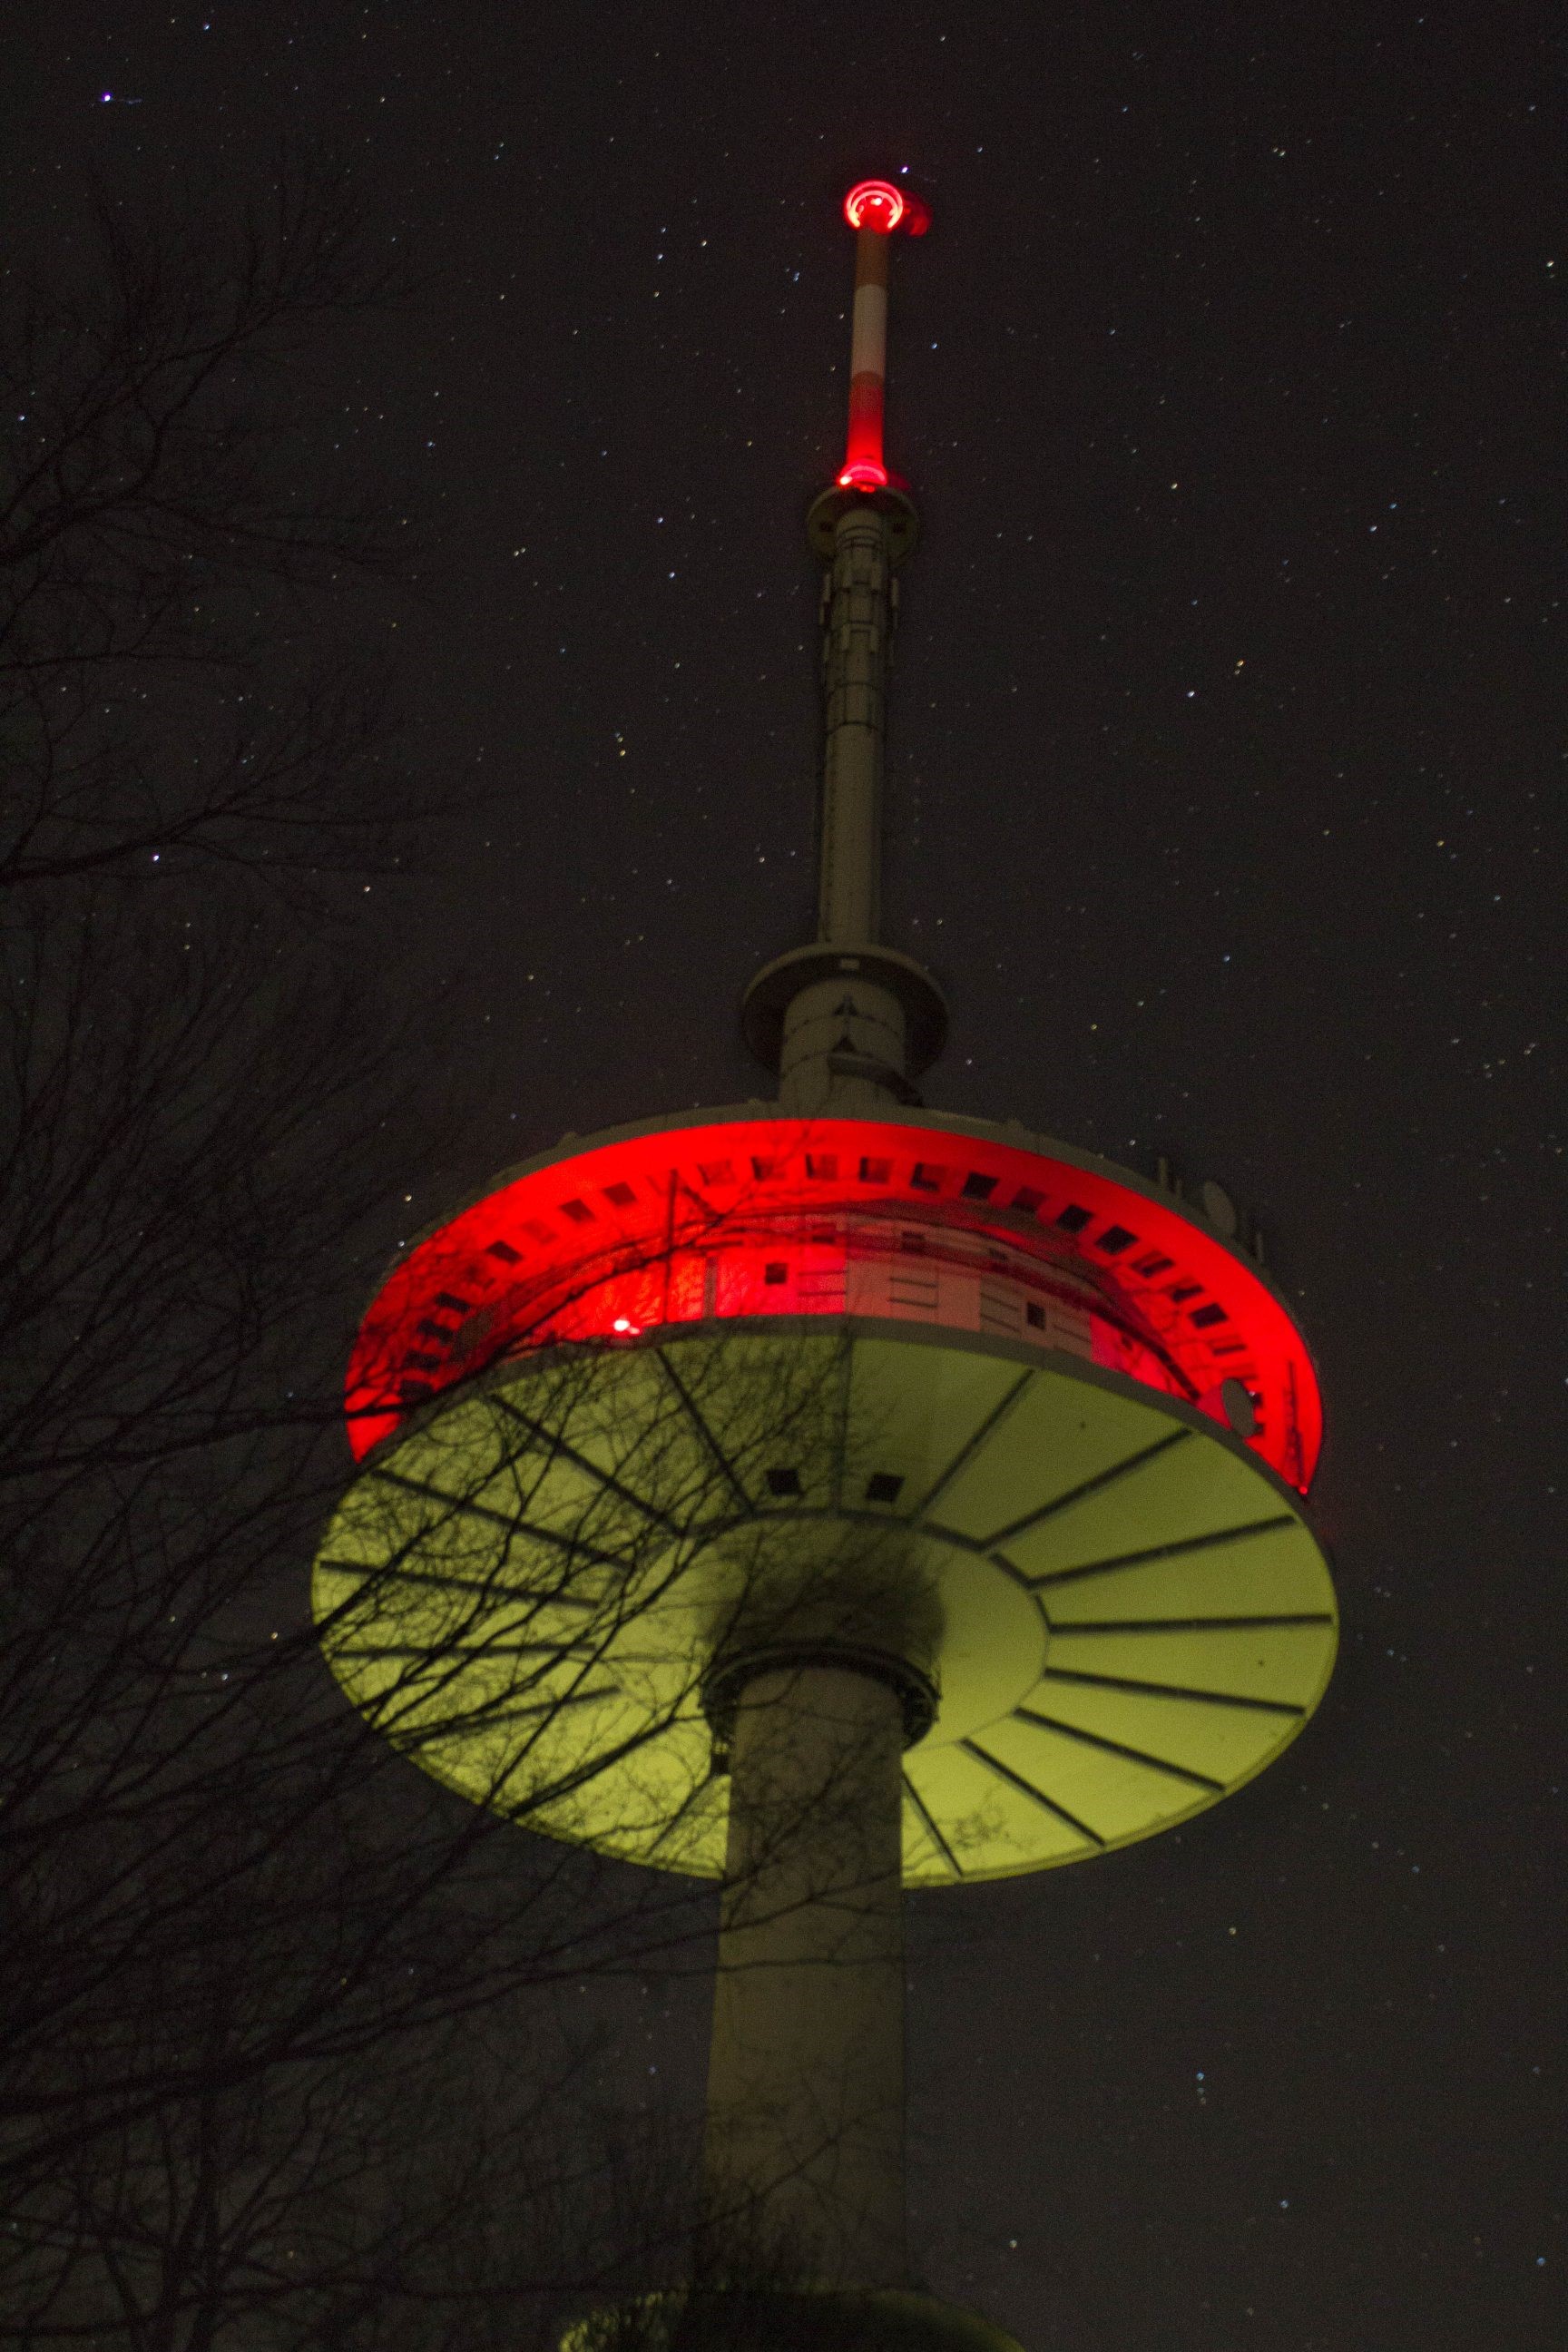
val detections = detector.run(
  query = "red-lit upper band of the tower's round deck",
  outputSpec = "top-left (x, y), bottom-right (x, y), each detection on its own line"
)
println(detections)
top-left (348, 1112), bottom-right (1321, 1494)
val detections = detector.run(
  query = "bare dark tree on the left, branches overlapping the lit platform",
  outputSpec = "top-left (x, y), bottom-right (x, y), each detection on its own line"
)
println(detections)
top-left (0, 181), bottom-right (912, 2352)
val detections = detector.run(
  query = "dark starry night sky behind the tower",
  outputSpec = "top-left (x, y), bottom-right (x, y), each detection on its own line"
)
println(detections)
top-left (18, 0), bottom-right (1565, 2352)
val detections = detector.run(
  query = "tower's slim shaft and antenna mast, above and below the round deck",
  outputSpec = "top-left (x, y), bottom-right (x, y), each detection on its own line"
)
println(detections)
top-left (705, 181), bottom-right (945, 2288)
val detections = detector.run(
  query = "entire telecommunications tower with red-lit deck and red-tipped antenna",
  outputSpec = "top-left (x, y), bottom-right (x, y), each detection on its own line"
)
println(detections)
top-left (315, 181), bottom-right (1336, 2352)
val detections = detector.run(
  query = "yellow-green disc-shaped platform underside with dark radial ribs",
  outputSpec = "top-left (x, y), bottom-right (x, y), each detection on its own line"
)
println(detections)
top-left (315, 1318), bottom-right (1336, 1886)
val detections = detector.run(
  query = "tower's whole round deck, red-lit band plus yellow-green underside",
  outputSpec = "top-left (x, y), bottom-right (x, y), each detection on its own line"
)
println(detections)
top-left (318, 1105), bottom-right (1336, 1884)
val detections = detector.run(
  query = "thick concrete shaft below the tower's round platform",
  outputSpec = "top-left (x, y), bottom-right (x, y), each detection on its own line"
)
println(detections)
top-left (705, 1665), bottom-right (907, 2286)
